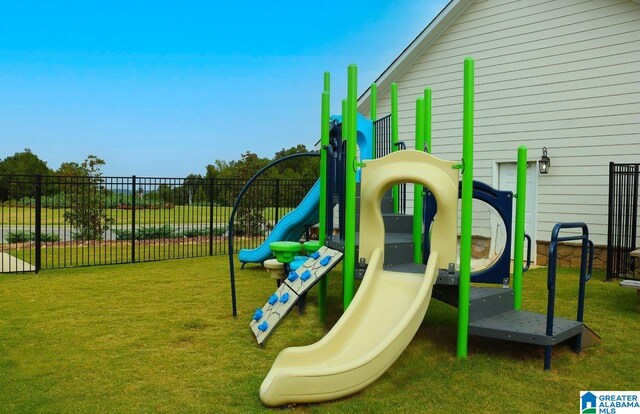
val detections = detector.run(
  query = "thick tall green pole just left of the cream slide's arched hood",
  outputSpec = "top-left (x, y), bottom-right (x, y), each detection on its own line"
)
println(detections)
top-left (342, 65), bottom-right (358, 310)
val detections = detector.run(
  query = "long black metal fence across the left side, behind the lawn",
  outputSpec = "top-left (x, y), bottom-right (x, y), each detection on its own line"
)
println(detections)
top-left (0, 175), bottom-right (314, 272)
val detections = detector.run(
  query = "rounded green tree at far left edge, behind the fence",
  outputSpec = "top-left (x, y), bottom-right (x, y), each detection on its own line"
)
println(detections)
top-left (0, 148), bottom-right (51, 201)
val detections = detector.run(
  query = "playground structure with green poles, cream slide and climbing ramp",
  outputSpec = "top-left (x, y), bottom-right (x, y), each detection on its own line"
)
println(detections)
top-left (230, 59), bottom-right (593, 406)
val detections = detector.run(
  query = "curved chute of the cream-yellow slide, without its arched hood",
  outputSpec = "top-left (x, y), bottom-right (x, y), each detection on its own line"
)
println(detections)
top-left (260, 249), bottom-right (437, 406)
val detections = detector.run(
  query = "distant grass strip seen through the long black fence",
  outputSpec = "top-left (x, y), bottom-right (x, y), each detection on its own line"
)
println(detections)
top-left (0, 206), bottom-right (293, 230)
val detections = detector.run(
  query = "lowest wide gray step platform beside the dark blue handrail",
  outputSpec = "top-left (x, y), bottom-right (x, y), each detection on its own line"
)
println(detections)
top-left (469, 310), bottom-right (584, 346)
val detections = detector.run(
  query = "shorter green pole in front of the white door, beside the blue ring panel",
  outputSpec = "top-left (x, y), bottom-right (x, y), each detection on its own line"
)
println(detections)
top-left (513, 146), bottom-right (527, 310)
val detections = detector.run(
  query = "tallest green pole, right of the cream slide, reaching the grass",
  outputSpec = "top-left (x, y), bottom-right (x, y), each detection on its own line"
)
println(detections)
top-left (457, 58), bottom-right (473, 359)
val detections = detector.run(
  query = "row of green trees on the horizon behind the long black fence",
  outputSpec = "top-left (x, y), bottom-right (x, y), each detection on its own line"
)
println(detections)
top-left (0, 145), bottom-right (319, 240)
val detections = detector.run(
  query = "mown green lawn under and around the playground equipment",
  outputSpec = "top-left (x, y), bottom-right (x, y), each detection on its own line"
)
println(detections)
top-left (0, 257), bottom-right (640, 413)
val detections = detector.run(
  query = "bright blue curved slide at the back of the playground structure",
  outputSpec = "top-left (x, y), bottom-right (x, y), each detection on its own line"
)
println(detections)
top-left (238, 180), bottom-right (320, 263)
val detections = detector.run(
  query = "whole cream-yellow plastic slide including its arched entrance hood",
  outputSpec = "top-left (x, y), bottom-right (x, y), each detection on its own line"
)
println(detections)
top-left (260, 151), bottom-right (458, 406)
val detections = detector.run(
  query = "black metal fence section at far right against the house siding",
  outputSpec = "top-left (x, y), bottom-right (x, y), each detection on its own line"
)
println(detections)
top-left (607, 163), bottom-right (640, 279)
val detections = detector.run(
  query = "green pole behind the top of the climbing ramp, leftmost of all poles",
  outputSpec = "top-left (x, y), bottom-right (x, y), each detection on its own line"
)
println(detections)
top-left (318, 72), bottom-right (331, 323)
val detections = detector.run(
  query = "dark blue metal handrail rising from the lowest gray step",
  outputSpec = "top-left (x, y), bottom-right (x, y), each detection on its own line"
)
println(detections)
top-left (544, 222), bottom-right (593, 370)
